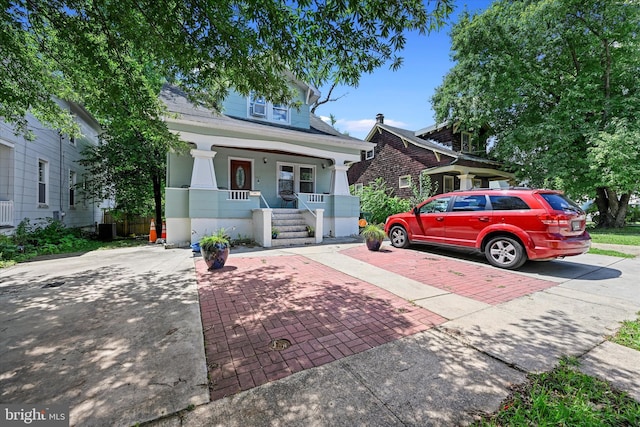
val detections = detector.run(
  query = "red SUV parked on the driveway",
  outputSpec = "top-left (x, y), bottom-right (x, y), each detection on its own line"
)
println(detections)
top-left (385, 188), bottom-right (591, 269)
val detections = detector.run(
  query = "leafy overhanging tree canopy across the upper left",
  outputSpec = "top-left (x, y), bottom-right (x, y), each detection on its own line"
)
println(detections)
top-left (6, 0), bottom-right (452, 236)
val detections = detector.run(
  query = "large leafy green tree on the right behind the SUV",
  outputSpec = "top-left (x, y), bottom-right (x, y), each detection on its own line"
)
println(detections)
top-left (432, 0), bottom-right (640, 227)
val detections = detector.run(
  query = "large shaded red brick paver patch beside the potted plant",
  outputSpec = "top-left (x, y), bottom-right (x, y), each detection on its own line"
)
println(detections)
top-left (196, 255), bottom-right (446, 400)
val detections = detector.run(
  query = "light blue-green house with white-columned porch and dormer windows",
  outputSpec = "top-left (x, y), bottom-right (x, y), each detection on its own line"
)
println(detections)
top-left (161, 82), bottom-right (373, 247)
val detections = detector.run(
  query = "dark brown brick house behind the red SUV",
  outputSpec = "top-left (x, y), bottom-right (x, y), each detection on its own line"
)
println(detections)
top-left (348, 114), bottom-right (514, 197)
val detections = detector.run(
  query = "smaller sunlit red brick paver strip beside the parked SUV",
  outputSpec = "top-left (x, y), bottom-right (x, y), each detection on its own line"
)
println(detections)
top-left (340, 244), bottom-right (558, 305)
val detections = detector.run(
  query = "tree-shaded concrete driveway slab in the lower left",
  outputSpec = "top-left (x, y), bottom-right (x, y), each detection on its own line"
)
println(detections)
top-left (0, 246), bottom-right (209, 426)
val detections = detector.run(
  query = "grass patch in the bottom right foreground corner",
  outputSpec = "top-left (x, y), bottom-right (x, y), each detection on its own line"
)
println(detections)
top-left (473, 358), bottom-right (640, 427)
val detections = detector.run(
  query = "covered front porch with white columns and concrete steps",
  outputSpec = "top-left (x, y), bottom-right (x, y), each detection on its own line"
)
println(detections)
top-left (165, 131), bottom-right (361, 247)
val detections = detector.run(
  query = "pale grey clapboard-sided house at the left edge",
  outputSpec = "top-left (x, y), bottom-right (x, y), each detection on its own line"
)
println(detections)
top-left (0, 101), bottom-right (102, 234)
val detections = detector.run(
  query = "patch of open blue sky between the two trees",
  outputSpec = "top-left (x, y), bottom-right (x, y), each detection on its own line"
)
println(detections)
top-left (316, 0), bottom-right (491, 139)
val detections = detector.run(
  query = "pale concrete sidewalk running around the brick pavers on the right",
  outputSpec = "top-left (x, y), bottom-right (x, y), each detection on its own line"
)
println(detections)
top-left (153, 244), bottom-right (640, 426)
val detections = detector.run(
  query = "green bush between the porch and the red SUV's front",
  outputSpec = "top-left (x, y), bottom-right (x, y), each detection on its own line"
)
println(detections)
top-left (352, 178), bottom-right (411, 224)
